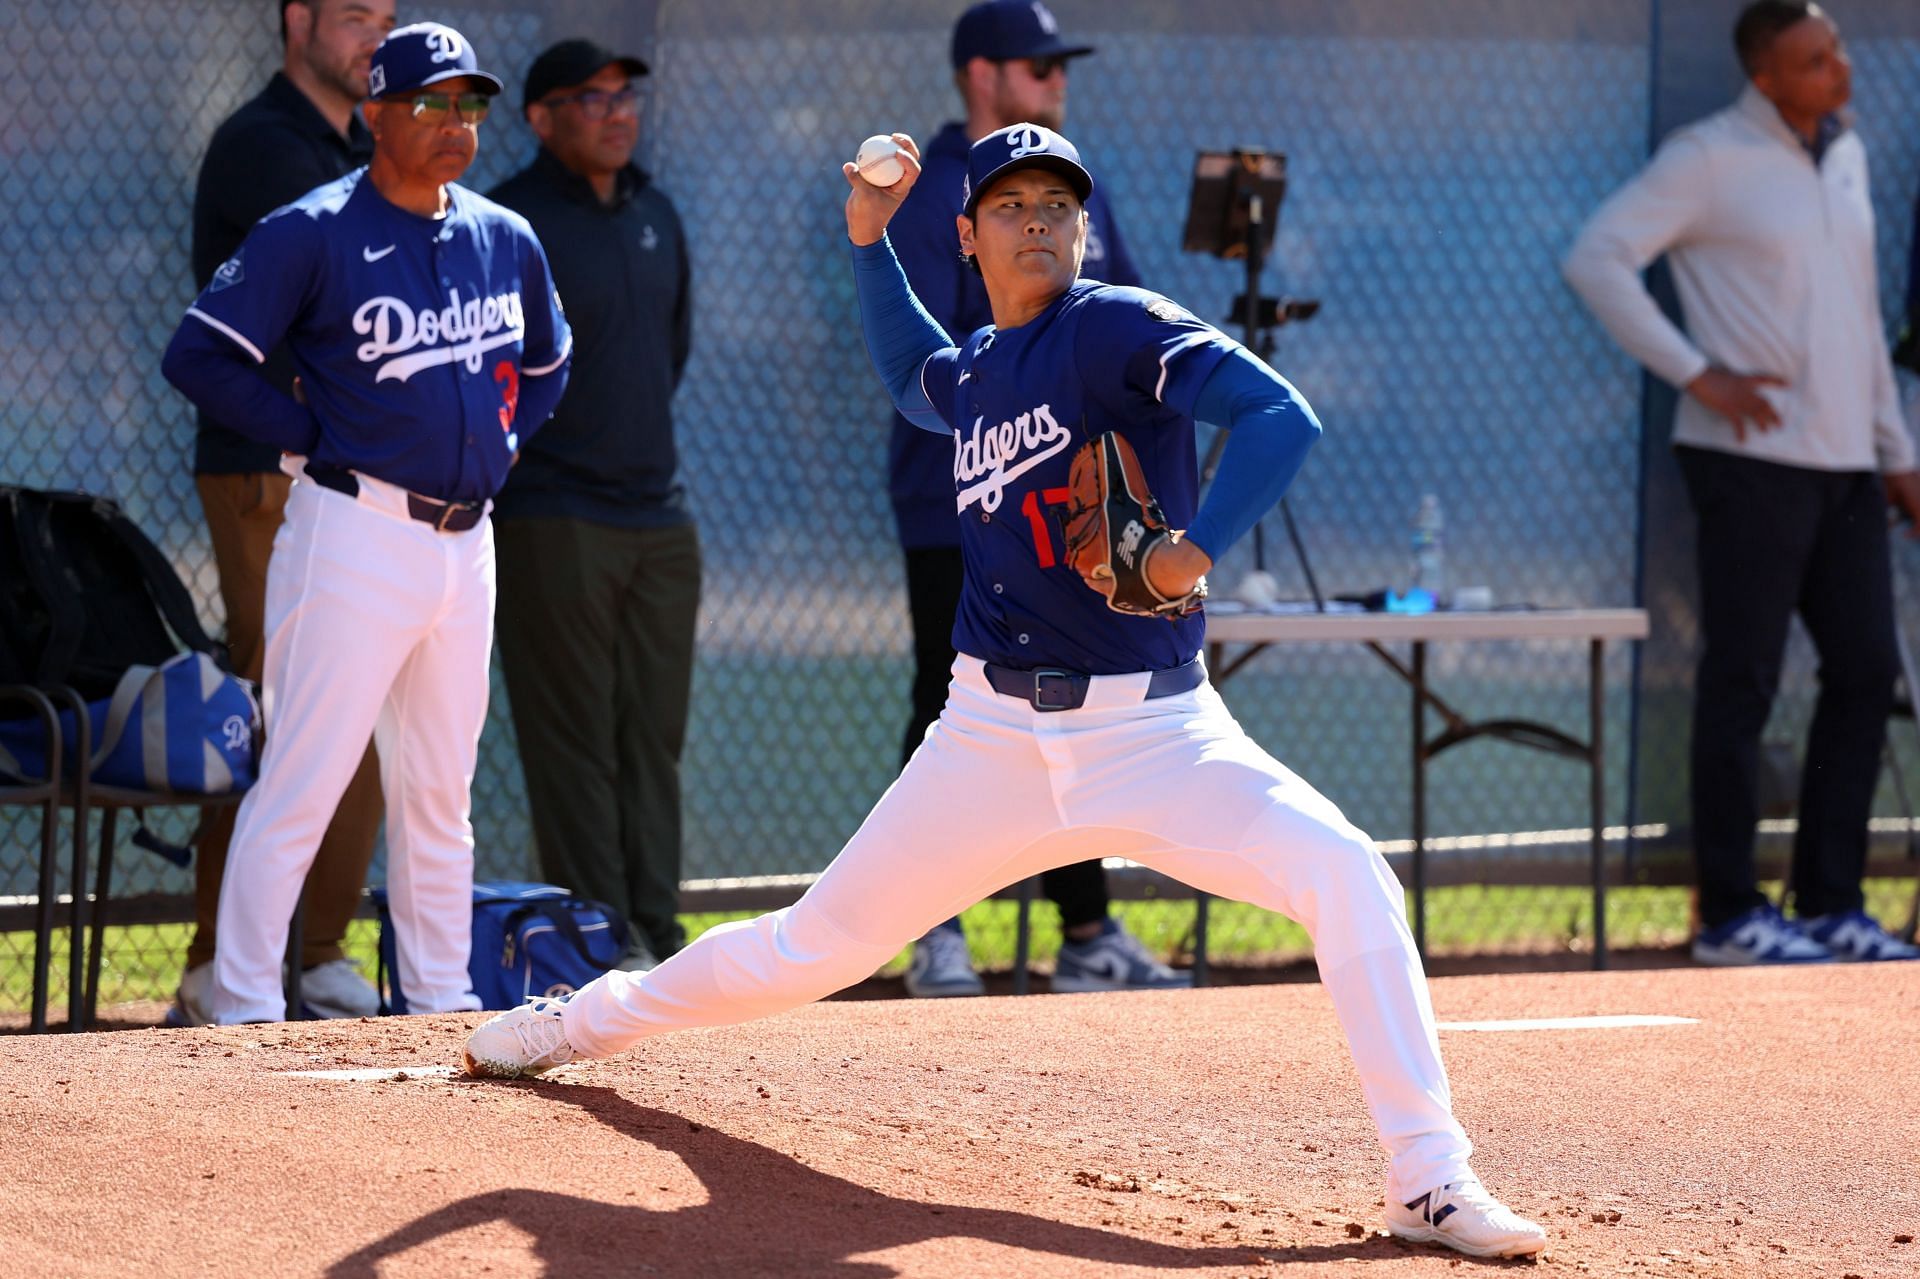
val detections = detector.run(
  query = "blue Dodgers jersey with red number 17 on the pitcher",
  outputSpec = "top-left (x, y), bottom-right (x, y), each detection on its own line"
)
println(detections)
top-left (920, 280), bottom-right (1238, 674)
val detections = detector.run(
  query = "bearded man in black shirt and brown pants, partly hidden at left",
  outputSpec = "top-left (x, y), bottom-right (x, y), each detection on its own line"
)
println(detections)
top-left (167, 0), bottom-right (394, 1026)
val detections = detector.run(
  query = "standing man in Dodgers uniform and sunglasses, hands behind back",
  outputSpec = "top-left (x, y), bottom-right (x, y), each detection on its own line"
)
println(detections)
top-left (163, 23), bottom-right (570, 1024)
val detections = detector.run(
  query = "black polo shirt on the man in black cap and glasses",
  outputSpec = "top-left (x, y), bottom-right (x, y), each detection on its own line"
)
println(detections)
top-left (488, 148), bottom-right (693, 528)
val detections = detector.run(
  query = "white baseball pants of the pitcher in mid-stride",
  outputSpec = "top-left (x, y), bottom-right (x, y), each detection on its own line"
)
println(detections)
top-left (563, 655), bottom-right (1473, 1200)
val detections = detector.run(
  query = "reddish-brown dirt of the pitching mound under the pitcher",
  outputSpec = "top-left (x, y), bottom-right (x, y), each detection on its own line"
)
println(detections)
top-left (0, 964), bottom-right (1920, 1279)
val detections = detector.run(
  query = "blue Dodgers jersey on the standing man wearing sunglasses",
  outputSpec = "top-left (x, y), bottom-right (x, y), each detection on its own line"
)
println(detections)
top-left (188, 169), bottom-right (572, 501)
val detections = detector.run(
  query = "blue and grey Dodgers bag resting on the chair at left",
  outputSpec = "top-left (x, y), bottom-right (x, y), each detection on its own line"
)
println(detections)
top-left (0, 653), bottom-right (259, 795)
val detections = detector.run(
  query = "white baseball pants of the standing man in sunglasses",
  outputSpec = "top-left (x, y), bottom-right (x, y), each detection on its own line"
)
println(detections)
top-left (213, 476), bottom-right (493, 1026)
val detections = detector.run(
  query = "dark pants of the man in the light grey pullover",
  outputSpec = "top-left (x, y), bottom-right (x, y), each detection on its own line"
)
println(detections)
top-left (1674, 447), bottom-right (1899, 928)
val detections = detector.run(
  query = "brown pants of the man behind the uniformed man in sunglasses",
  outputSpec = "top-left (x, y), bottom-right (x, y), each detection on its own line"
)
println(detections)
top-left (186, 472), bottom-right (382, 968)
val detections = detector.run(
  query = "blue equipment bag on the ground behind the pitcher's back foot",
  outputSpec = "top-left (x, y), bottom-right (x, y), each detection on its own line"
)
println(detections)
top-left (372, 880), bottom-right (626, 1012)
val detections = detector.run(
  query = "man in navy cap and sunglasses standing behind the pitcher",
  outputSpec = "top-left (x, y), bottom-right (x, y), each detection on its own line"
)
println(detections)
top-left (887, 0), bottom-right (1167, 997)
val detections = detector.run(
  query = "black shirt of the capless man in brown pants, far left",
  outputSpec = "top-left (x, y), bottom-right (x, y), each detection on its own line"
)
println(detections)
top-left (194, 71), bottom-right (372, 474)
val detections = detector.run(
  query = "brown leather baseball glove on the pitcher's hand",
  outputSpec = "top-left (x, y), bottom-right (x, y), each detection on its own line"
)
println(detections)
top-left (1064, 430), bottom-right (1206, 620)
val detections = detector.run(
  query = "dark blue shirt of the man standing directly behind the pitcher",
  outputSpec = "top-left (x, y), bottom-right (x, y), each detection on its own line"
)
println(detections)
top-left (887, 123), bottom-right (1140, 549)
